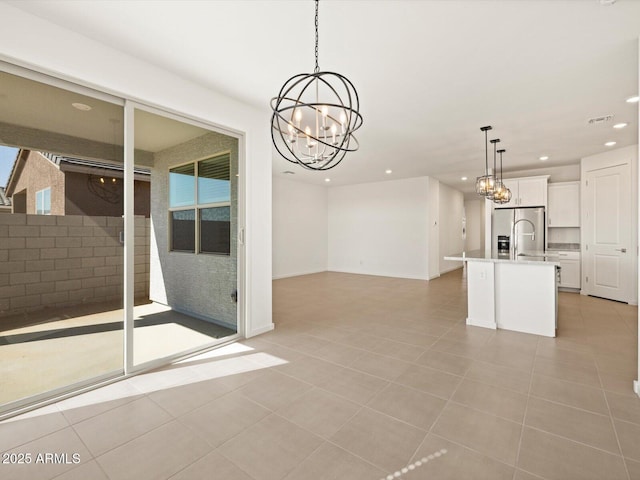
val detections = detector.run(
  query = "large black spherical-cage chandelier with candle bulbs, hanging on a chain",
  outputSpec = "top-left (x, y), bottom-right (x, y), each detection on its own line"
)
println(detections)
top-left (271, 0), bottom-right (362, 170)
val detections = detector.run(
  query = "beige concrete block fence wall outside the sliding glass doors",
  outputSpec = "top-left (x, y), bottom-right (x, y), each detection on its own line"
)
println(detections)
top-left (0, 213), bottom-right (150, 318)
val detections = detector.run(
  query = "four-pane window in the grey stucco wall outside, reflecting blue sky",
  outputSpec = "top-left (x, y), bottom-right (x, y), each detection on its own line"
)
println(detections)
top-left (169, 153), bottom-right (231, 255)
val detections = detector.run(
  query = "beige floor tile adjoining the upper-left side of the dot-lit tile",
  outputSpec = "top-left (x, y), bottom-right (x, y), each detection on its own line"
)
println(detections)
top-left (331, 408), bottom-right (426, 472)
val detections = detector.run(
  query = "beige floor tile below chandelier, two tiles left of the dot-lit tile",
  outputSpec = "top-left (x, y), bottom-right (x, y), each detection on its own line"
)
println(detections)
top-left (276, 388), bottom-right (361, 438)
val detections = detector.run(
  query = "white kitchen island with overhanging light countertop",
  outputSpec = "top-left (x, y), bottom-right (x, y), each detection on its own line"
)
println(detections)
top-left (444, 250), bottom-right (560, 337)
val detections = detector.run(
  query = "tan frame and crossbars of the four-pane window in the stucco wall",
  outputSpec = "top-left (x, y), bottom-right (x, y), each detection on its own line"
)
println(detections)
top-left (167, 150), bottom-right (233, 257)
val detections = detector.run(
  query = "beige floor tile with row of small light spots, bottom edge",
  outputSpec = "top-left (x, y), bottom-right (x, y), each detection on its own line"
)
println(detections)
top-left (400, 434), bottom-right (514, 480)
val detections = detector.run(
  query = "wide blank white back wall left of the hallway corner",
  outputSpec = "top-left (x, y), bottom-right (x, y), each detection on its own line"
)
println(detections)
top-left (328, 177), bottom-right (429, 279)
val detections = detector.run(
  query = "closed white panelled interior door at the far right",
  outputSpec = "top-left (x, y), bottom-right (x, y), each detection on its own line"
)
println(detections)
top-left (584, 164), bottom-right (634, 302)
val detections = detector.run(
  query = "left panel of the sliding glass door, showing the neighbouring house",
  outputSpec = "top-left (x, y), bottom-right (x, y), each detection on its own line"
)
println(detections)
top-left (0, 66), bottom-right (126, 413)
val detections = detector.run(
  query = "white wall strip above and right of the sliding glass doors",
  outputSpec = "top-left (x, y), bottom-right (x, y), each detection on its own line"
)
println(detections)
top-left (0, 3), bottom-right (273, 336)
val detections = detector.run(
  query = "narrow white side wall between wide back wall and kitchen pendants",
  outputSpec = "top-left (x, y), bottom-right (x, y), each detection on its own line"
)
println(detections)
top-left (438, 183), bottom-right (464, 275)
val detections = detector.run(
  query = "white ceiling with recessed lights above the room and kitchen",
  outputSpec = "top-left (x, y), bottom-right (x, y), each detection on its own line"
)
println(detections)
top-left (8, 0), bottom-right (640, 192)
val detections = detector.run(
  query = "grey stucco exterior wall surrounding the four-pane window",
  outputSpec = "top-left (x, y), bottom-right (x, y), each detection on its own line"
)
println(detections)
top-left (150, 132), bottom-right (238, 327)
